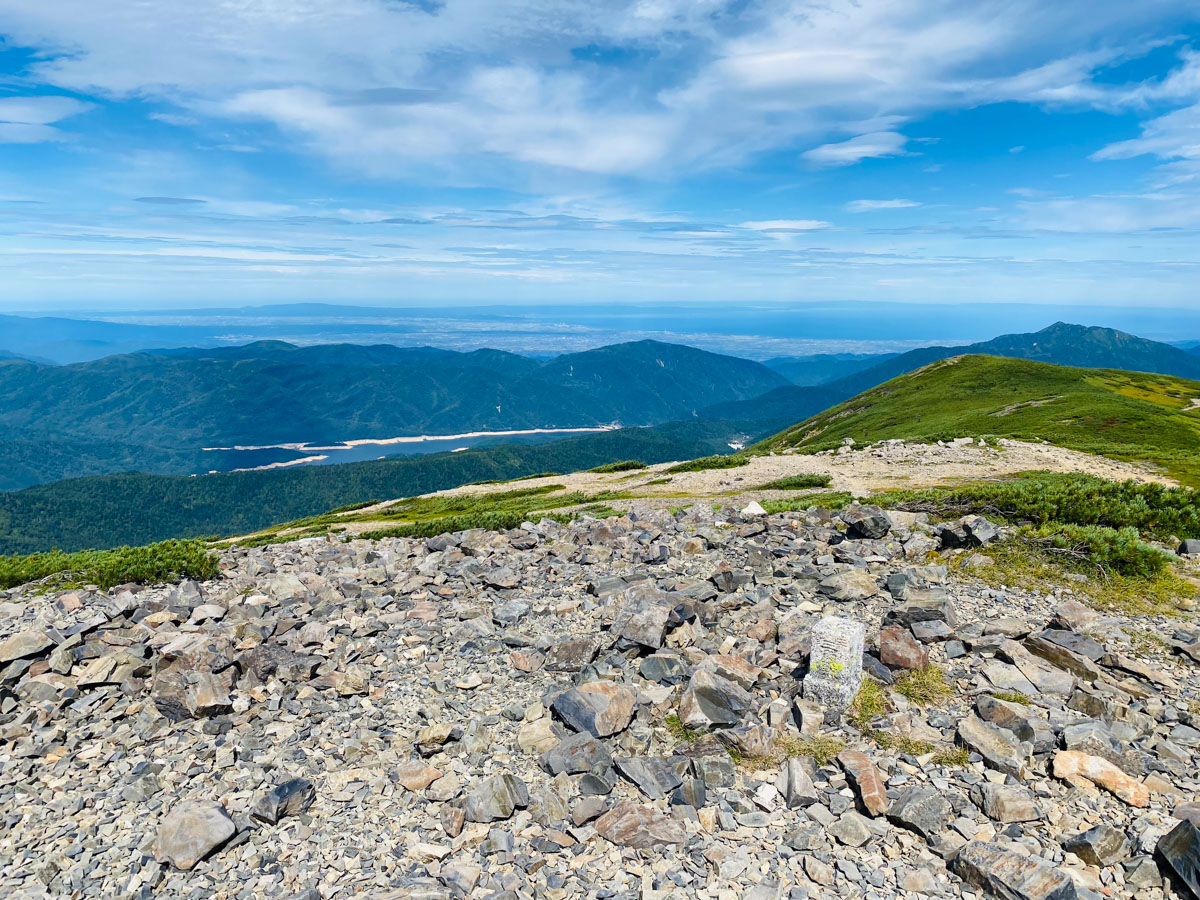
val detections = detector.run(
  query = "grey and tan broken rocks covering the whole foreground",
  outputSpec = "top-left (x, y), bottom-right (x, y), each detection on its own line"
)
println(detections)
top-left (0, 494), bottom-right (1200, 900)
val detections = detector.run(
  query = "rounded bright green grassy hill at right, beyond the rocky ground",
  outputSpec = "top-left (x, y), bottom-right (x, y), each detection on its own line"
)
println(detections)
top-left (754, 356), bottom-right (1200, 487)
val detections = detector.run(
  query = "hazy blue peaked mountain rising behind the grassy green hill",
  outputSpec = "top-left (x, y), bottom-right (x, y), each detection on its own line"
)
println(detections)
top-left (828, 322), bottom-right (1200, 395)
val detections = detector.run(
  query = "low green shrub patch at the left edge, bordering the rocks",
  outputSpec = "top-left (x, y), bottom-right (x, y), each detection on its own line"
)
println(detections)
top-left (0, 540), bottom-right (217, 590)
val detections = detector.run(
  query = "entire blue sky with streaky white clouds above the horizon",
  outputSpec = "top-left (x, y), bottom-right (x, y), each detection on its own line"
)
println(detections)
top-left (0, 0), bottom-right (1200, 310)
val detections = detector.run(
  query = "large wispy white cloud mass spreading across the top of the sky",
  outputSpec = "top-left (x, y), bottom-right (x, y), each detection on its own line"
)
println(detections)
top-left (4, 0), bottom-right (1198, 181)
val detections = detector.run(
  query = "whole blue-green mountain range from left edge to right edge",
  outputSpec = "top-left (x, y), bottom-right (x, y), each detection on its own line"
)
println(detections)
top-left (0, 319), bottom-right (1200, 490)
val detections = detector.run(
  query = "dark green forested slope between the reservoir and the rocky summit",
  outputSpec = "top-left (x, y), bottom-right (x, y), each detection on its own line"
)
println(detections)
top-left (0, 420), bottom-right (768, 554)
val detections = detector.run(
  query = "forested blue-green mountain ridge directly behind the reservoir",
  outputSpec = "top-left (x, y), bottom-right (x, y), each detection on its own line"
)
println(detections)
top-left (0, 341), bottom-right (787, 490)
